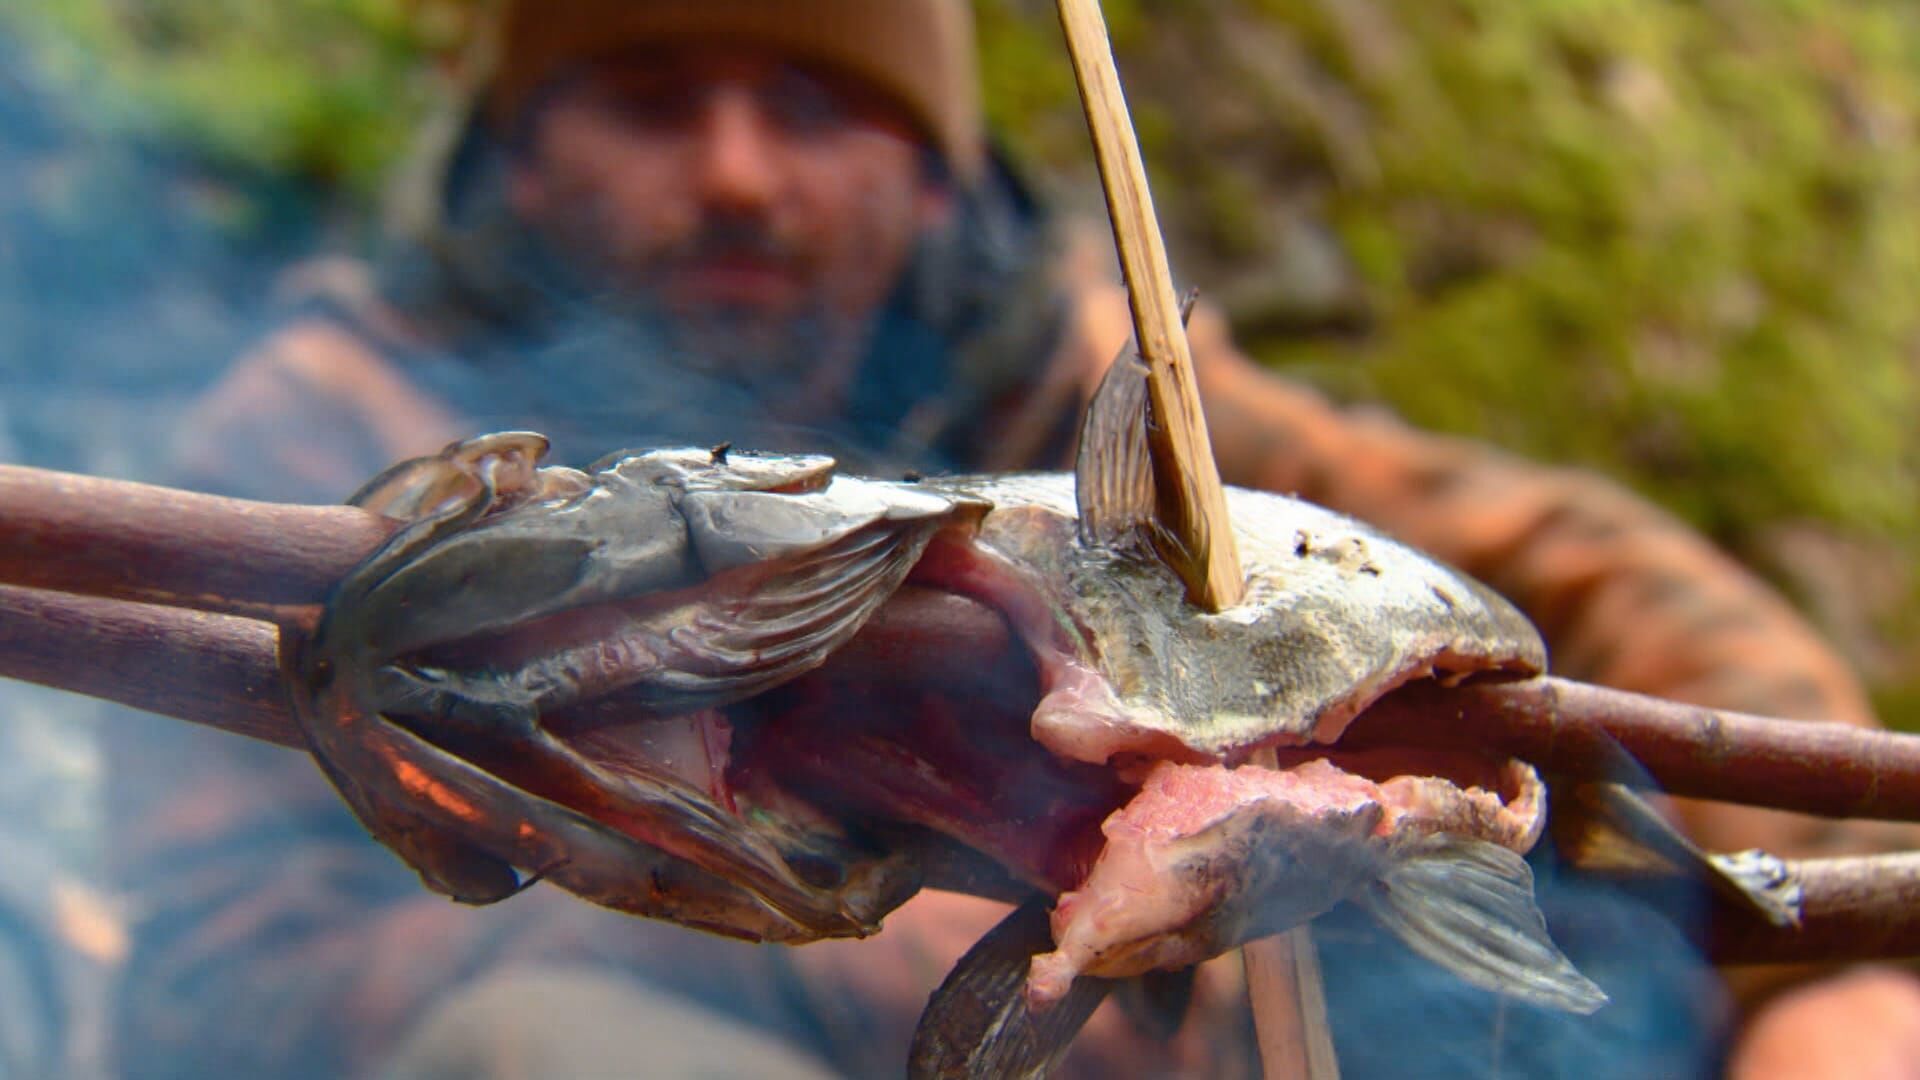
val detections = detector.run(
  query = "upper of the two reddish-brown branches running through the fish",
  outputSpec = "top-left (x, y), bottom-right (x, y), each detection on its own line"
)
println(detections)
top-left (0, 467), bottom-right (1920, 821)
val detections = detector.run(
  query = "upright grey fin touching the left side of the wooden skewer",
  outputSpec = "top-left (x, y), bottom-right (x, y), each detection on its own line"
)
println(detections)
top-left (1073, 342), bottom-right (1156, 548)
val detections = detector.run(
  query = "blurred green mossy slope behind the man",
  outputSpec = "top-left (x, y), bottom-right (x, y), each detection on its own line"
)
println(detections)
top-left (0, 0), bottom-right (1920, 726)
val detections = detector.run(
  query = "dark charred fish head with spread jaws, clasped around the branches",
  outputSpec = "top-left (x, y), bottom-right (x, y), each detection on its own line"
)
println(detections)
top-left (288, 436), bottom-right (985, 942)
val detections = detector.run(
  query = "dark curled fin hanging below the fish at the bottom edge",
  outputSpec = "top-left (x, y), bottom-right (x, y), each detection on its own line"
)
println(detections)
top-left (906, 897), bottom-right (1114, 1080)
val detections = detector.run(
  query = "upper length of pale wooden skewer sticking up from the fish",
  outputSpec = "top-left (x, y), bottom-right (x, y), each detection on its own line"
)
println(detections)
top-left (1060, 0), bottom-right (1244, 611)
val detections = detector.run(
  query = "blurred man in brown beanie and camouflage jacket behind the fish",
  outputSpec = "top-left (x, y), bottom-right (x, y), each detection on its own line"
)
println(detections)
top-left (115, 0), bottom-right (1920, 1076)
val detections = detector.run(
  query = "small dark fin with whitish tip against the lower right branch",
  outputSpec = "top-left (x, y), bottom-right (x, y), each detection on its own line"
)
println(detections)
top-left (1551, 782), bottom-right (1803, 928)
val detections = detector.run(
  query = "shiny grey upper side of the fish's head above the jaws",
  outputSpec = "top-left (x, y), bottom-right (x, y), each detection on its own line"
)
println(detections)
top-left (339, 432), bottom-right (977, 655)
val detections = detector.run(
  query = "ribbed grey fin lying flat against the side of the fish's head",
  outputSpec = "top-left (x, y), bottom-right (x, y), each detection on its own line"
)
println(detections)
top-left (634, 521), bottom-right (941, 709)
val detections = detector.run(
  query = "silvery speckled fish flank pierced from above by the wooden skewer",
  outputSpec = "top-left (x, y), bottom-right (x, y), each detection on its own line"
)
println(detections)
top-left (937, 475), bottom-right (1546, 763)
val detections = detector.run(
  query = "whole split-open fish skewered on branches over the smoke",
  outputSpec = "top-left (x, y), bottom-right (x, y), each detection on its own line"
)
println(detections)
top-left (288, 361), bottom-right (1605, 1074)
